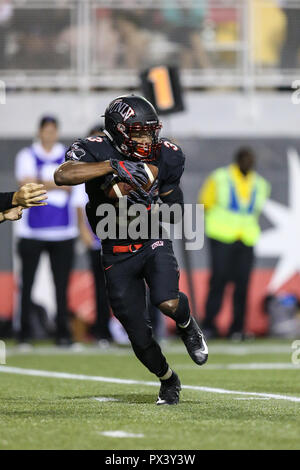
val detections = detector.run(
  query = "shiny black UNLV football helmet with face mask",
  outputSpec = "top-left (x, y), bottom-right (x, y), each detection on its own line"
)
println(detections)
top-left (104, 95), bottom-right (162, 161)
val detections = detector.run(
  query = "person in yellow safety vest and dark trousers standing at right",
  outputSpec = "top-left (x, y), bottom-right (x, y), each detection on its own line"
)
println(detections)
top-left (198, 147), bottom-right (271, 339)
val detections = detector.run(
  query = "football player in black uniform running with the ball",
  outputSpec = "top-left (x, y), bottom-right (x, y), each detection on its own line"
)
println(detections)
top-left (55, 95), bottom-right (208, 405)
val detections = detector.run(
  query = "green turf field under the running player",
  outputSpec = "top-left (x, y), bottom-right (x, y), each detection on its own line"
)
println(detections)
top-left (0, 340), bottom-right (300, 450)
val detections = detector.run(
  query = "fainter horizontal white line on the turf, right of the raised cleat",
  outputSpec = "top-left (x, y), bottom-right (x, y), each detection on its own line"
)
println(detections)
top-left (174, 362), bottom-right (300, 371)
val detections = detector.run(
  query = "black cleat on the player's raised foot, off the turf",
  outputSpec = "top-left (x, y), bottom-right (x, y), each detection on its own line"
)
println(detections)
top-left (177, 316), bottom-right (208, 366)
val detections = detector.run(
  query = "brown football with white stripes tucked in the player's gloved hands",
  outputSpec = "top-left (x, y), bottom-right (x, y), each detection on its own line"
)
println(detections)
top-left (104, 163), bottom-right (158, 200)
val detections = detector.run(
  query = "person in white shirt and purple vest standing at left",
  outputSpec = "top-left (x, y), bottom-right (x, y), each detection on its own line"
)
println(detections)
top-left (15, 116), bottom-right (78, 346)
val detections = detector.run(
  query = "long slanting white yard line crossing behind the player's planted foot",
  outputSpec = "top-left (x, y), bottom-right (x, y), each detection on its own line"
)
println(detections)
top-left (0, 366), bottom-right (300, 403)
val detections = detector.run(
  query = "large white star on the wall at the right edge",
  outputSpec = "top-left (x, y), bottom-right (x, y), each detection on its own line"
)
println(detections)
top-left (256, 148), bottom-right (300, 292)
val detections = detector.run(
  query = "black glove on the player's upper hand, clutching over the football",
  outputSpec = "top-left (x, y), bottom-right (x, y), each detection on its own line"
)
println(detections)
top-left (110, 158), bottom-right (148, 187)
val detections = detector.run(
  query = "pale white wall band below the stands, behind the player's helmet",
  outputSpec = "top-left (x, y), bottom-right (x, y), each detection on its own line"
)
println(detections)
top-left (0, 89), bottom-right (300, 139)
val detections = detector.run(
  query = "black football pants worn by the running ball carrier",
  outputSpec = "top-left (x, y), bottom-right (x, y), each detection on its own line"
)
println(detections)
top-left (103, 240), bottom-right (179, 377)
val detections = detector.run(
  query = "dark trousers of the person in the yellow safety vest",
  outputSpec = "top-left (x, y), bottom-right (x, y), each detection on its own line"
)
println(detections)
top-left (203, 238), bottom-right (254, 335)
